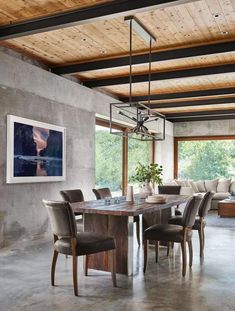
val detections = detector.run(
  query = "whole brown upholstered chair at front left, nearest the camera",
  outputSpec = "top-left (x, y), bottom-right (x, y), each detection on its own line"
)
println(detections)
top-left (43, 200), bottom-right (116, 296)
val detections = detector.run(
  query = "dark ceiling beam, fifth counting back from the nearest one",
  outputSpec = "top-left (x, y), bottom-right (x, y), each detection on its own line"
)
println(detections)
top-left (148, 96), bottom-right (235, 109)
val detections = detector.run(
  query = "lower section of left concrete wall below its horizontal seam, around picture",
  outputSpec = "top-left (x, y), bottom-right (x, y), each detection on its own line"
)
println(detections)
top-left (0, 87), bottom-right (95, 244)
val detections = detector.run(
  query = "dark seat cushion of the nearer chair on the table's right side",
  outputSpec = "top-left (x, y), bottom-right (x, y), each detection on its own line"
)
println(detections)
top-left (144, 224), bottom-right (192, 243)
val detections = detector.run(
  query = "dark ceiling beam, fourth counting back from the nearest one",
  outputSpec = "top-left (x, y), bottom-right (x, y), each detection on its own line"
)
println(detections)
top-left (119, 87), bottom-right (235, 102)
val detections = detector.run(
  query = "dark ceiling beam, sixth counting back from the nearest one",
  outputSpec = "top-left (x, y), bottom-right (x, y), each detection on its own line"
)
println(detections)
top-left (165, 109), bottom-right (235, 120)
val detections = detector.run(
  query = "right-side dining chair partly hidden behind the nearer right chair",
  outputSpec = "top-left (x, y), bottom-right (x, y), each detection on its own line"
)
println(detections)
top-left (168, 192), bottom-right (214, 257)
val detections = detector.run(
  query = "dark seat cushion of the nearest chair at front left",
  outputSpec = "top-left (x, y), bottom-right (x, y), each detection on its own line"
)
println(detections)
top-left (54, 232), bottom-right (115, 256)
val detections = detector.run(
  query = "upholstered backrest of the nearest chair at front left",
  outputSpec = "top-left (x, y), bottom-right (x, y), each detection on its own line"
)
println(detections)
top-left (43, 200), bottom-right (77, 238)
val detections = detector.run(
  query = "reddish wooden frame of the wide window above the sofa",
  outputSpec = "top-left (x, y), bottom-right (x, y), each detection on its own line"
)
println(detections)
top-left (174, 135), bottom-right (235, 179)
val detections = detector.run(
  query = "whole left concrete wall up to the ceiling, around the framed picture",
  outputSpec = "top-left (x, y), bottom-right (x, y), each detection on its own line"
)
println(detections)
top-left (0, 53), bottom-right (118, 245)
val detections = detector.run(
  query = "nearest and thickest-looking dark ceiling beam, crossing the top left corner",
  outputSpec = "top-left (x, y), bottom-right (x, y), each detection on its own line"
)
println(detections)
top-left (0, 0), bottom-right (195, 40)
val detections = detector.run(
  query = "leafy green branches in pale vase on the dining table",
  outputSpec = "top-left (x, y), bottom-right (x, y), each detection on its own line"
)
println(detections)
top-left (131, 162), bottom-right (163, 198)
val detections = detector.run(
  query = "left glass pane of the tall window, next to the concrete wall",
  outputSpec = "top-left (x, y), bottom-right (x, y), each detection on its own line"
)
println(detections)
top-left (96, 125), bottom-right (122, 195)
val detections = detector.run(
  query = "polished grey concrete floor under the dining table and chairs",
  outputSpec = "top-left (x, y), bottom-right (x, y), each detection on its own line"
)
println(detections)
top-left (0, 213), bottom-right (235, 311)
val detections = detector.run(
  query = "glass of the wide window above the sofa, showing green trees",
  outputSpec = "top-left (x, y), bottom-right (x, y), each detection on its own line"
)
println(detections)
top-left (176, 137), bottom-right (235, 180)
